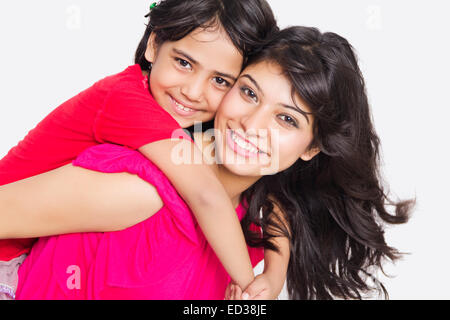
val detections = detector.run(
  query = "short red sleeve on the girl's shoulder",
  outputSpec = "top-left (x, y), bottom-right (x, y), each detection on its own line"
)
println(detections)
top-left (94, 83), bottom-right (191, 149)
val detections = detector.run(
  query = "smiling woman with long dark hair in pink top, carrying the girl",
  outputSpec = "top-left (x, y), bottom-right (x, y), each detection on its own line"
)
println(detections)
top-left (0, 27), bottom-right (412, 299)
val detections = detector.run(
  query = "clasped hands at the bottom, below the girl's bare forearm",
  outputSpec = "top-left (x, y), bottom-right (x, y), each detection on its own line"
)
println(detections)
top-left (225, 273), bottom-right (279, 300)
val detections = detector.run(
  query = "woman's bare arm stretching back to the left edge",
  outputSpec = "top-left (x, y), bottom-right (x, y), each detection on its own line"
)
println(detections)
top-left (0, 165), bottom-right (163, 239)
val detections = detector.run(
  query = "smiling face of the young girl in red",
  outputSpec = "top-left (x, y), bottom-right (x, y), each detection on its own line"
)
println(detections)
top-left (145, 27), bottom-right (243, 128)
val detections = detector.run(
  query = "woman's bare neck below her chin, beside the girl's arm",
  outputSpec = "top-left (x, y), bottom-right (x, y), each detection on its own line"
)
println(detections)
top-left (194, 133), bottom-right (260, 207)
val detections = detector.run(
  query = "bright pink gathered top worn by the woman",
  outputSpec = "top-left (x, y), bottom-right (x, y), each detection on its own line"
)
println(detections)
top-left (16, 144), bottom-right (264, 300)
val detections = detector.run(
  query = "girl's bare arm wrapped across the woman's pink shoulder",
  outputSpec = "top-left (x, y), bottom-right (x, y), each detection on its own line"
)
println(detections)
top-left (140, 140), bottom-right (254, 289)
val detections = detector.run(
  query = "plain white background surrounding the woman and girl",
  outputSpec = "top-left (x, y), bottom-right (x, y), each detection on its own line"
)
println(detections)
top-left (0, 0), bottom-right (450, 299)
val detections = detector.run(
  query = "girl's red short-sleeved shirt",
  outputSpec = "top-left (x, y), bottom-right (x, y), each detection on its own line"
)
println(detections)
top-left (0, 65), bottom-right (186, 261)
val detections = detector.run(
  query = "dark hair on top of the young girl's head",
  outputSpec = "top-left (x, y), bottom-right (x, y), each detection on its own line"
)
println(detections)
top-left (135, 0), bottom-right (278, 70)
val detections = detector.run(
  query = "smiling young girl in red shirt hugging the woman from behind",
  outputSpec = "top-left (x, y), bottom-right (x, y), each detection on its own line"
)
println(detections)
top-left (0, 0), bottom-right (276, 300)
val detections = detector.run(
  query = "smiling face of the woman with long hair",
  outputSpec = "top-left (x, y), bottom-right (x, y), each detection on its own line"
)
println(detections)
top-left (215, 61), bottom-right (319, 176)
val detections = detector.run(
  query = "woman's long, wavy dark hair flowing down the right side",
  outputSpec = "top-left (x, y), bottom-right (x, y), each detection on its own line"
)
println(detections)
top-left (242, 27), bottom-right (415, 299)
